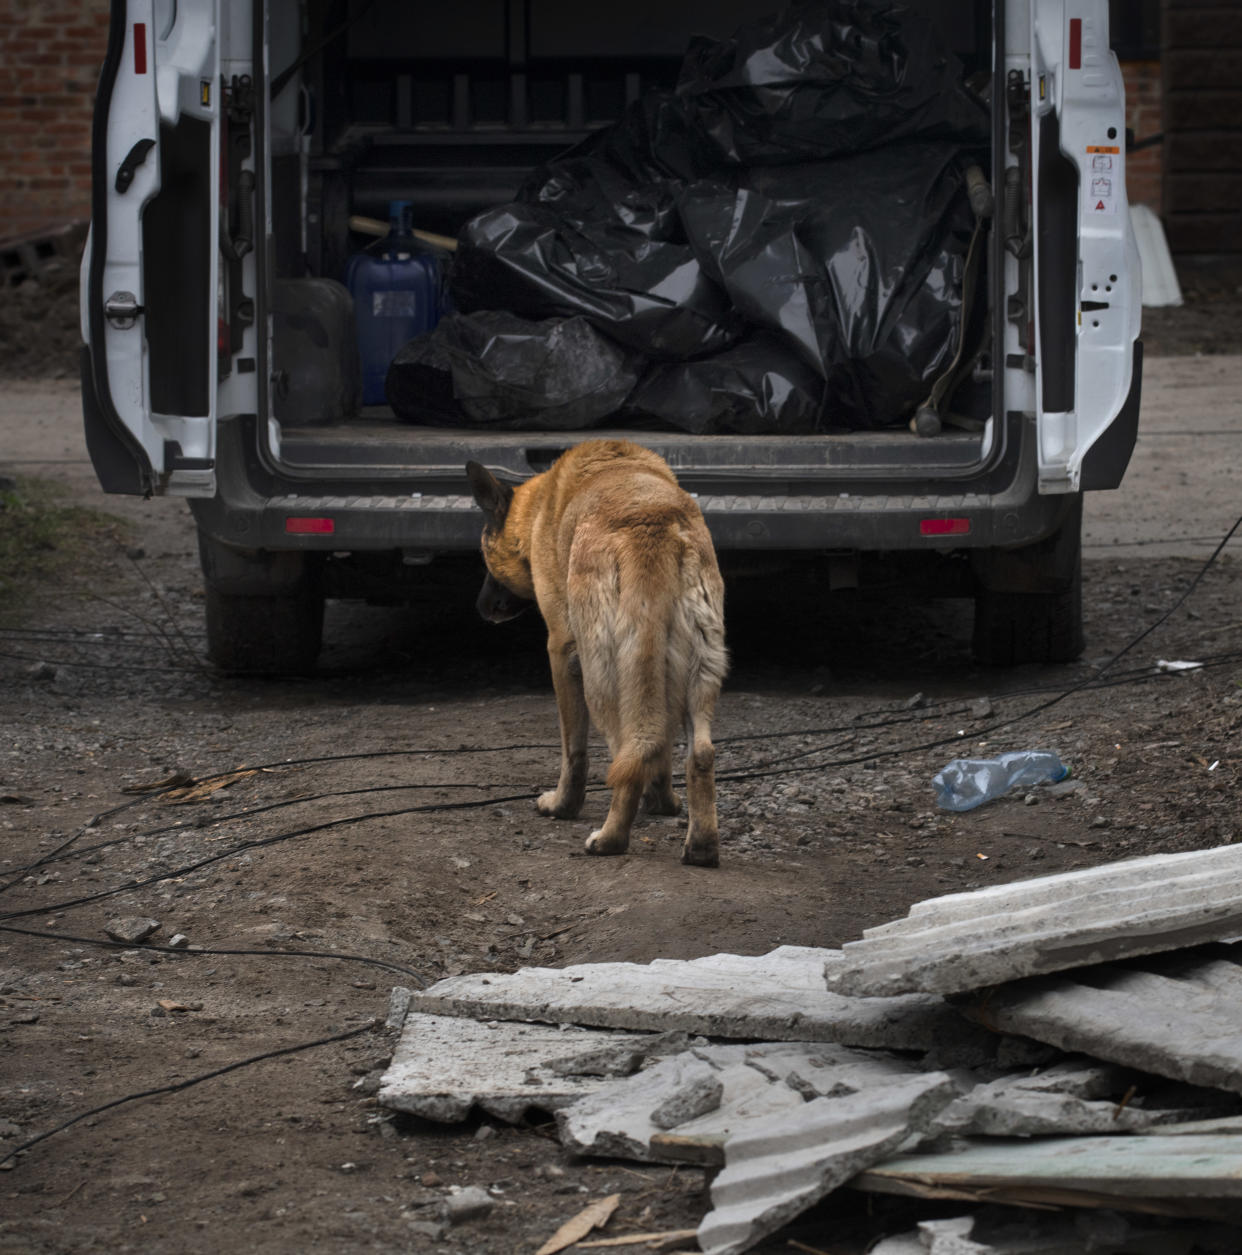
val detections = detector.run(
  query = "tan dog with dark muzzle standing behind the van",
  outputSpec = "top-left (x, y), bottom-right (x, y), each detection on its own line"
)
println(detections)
top-left (465, 441), bottom-right (729, 867)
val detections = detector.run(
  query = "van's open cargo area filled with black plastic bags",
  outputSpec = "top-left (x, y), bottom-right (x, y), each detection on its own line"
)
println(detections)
top-left (264, 0), bottom-right (992, 471)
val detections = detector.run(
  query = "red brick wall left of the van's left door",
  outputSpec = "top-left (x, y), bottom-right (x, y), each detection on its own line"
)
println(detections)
top-left (0, 0), bottom-right (108, 238)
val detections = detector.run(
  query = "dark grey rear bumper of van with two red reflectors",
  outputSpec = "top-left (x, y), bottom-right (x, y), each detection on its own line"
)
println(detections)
top-left (191, 404), bottom-right (1093, 555)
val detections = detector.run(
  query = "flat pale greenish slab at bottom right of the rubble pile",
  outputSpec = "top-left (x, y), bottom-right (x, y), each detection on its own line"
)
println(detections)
top-left (849, 1133), bottom-right (1242, 1219)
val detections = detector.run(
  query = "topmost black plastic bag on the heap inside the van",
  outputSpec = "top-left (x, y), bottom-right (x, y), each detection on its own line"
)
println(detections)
top-left (676, 0), bottom-right (989, 166)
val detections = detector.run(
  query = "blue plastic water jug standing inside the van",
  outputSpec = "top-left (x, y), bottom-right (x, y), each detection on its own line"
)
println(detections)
top-left (345, 201), bottom-right (442, 405)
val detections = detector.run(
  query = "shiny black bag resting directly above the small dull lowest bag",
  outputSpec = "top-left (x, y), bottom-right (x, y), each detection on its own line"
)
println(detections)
top-left (450, 195), bottom-right (739, 360)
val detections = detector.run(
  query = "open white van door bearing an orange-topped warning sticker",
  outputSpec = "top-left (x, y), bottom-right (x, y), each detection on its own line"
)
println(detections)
top-left (1030, 0), bottom-right (1142, 493)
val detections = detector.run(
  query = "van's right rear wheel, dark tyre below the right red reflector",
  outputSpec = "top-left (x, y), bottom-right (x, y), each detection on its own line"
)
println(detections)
top-left (975, 505), bottom-right (1084, 666)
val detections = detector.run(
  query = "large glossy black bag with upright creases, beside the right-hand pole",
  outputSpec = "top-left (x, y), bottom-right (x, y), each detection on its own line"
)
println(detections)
top-left (681, 144), bottom-right (975, 427)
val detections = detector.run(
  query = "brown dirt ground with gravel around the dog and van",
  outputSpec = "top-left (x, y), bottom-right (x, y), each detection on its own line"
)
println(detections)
top-left (0, 259), bottom-right (1242, 1255)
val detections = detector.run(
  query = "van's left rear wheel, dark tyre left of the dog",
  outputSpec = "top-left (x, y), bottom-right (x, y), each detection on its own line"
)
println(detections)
top-left (204, 581), bottom-right (324, 675)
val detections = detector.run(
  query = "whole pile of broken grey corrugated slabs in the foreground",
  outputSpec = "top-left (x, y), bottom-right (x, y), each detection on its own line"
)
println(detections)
top-left (379, 847), bottom-right (1242, 1255)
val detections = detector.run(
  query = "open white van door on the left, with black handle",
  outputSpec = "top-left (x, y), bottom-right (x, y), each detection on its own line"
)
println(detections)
top-left (82, 0), bottom-right (258, 496)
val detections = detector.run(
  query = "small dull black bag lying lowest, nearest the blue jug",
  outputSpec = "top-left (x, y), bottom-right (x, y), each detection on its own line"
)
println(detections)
top-left (385, 310), bottom-right (641, 430)
